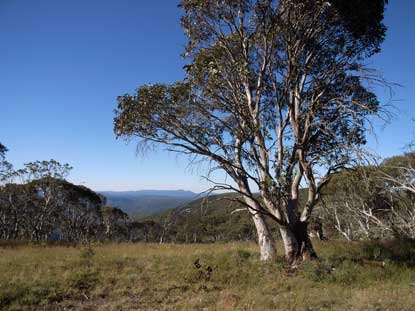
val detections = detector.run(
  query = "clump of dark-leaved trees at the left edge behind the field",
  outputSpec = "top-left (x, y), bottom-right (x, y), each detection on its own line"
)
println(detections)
top-left (0, 160), bottom-right (105, 241)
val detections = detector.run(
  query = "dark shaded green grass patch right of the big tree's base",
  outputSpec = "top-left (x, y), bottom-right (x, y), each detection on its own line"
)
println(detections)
top-left (300, 240), bottom-right (415, 287)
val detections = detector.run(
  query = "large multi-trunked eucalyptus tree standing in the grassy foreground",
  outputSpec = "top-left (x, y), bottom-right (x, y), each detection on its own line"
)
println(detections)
top-left (114, 0), bottom-right (386, 264)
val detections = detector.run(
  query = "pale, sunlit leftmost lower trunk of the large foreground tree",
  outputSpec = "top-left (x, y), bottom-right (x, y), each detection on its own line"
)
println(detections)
top-left (251, 213), bottom-right (276, 261)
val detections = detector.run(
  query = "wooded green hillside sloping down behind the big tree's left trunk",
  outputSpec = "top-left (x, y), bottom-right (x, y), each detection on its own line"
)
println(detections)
top-left (139, 194), bottom-right (276, 243)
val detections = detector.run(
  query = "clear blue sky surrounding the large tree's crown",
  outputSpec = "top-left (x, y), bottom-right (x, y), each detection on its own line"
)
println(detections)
top-left (0, 0), bottom-right (415, 191)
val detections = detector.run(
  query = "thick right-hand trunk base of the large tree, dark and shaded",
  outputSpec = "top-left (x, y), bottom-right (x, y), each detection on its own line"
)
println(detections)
top-left (280, 221), bottom-right (317, 267)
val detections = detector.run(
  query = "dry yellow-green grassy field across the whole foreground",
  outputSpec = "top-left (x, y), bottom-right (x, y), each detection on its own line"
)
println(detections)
top-left (0, 241), bottom-right (415, 311)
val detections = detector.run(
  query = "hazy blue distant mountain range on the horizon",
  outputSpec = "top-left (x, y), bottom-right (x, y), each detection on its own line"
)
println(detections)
top-left (99, 190), bottom-right (199, 217)
